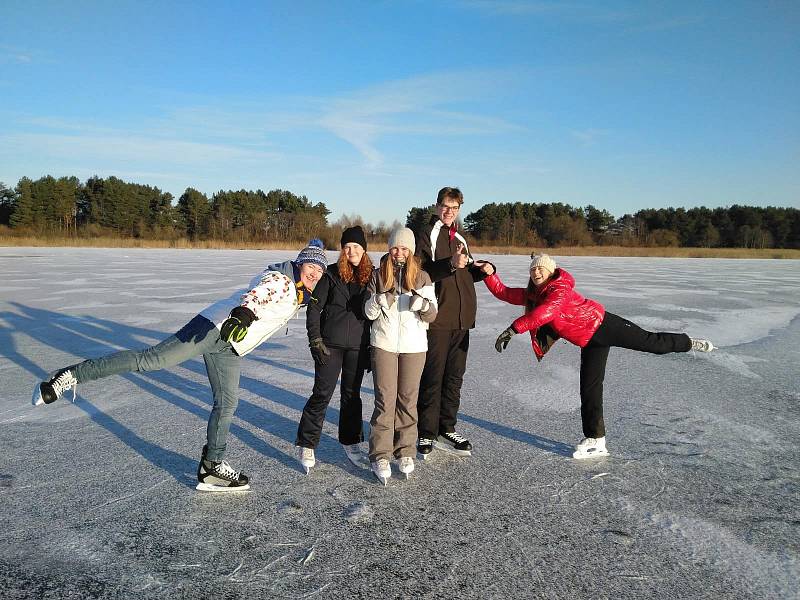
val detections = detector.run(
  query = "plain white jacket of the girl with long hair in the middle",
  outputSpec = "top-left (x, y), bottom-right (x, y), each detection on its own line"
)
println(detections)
top-left (364, 254), bottom-right (438, 354)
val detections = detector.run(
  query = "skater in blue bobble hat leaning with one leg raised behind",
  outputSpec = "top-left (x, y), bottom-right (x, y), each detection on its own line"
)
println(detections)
top-left (32, 240), bottom-right (328, 491)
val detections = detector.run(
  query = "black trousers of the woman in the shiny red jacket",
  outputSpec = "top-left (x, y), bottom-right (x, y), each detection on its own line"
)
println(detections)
top-left (581, 312), bottom-right (692, 438)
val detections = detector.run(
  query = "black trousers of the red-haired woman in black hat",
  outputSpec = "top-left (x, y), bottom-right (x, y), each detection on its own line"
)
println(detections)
top-left (295, 348), bottom-right (369, 448)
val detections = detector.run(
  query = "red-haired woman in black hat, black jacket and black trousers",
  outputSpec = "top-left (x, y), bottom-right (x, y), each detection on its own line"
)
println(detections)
top-left (295, 225), bottom-right (373, 473)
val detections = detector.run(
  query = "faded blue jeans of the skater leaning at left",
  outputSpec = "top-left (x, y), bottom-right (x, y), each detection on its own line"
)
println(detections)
top-left (68, 315), bottom-right (241, 461)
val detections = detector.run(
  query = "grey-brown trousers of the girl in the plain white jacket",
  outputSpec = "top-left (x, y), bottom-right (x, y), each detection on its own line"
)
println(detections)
top-left (369, 348), bottom-right (425, 462)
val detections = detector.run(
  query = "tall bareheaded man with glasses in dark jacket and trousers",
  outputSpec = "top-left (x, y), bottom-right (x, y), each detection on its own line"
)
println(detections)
top-left (416, 187), bottom-right (485, 458)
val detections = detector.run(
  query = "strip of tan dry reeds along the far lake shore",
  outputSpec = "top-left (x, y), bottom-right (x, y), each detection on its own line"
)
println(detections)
top-left (0, 236), bottom-right (800, 260)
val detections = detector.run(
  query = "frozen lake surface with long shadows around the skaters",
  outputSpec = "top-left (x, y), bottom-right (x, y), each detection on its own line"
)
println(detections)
top-left (0, 248), bottom-right (800, 599)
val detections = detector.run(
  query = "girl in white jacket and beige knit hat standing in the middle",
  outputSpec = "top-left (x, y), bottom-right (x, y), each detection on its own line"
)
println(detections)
top-left (364, 227), bottom-right (437, 485)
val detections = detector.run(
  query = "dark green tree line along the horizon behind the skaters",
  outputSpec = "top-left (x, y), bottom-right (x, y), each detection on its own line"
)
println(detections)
top-left (0, 175), bottom-right (800, 248)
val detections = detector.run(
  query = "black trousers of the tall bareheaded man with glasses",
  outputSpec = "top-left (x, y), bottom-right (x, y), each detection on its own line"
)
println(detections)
top-left (417, 329), bottom-right (469, 440)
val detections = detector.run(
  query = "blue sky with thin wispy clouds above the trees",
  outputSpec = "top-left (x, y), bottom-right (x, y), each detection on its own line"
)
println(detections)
top-left (0, 0), bottom-right (800, 223)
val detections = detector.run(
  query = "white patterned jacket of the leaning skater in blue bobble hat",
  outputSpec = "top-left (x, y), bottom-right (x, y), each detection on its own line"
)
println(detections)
top-left (200, 261), bottom-right (302, 356)
